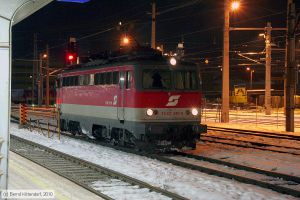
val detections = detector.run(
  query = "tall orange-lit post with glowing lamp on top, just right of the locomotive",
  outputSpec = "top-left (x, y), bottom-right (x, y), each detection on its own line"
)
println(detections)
top-left (221, 0), bottom-right (239, 122)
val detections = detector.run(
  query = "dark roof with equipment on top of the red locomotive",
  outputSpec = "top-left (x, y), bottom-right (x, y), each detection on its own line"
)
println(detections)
top-left (63, 48), bottom-right (196, 73)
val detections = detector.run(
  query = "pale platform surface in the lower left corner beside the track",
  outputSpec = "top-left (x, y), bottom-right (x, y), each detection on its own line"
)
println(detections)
top-left (8, 152), bottom-right (102, 200)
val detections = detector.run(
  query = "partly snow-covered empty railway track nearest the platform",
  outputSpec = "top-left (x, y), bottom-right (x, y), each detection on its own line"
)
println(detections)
top-left (10, 135), bottom-right (186, 200)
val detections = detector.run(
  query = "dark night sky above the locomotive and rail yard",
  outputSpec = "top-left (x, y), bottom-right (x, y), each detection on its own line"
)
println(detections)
top-left (13, 0), bottom-right (300, 66)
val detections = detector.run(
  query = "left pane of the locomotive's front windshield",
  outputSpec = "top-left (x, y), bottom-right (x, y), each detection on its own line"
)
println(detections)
top-left (143, 69), bottom-right (171, 89)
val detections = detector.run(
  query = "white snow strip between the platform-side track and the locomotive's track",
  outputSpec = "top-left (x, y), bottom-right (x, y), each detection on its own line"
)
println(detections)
top-left (10, 124), bottom-right (295, 200)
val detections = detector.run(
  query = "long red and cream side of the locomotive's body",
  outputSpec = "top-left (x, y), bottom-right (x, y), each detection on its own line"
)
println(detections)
top-left (57, 66), bottom-right (131, 138)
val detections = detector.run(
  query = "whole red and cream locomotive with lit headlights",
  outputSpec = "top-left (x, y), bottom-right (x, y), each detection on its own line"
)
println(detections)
top-left (57, 49), bottom-right (206, 149)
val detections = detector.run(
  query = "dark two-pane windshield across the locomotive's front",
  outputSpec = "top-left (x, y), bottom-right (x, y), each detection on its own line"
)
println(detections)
top-left (143, 69), bottom-right (198, 90)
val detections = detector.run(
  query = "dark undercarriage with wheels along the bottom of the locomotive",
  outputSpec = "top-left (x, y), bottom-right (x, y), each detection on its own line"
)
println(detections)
top-left (59, 110), bottom-right (201, 149)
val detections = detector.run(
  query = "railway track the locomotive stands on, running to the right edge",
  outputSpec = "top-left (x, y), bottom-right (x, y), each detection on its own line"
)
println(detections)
top-left (9, 119), bottom-right (300, 197)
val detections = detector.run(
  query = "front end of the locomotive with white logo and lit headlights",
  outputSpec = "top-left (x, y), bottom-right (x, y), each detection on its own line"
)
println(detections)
top-left (135, 59), bottom-right (206, 149)
